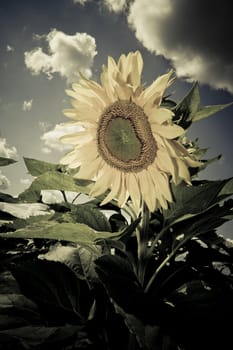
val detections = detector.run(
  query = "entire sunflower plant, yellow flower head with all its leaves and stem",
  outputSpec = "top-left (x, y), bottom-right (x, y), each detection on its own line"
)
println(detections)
top-left (0, 51), bottom-right (233, 350)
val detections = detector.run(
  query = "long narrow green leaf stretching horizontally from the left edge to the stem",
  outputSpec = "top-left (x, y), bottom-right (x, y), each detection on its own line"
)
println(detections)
top-left (0, 220), bottom-right (121, 244)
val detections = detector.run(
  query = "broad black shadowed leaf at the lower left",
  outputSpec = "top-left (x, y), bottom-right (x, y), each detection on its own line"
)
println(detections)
top-left (11, 260), bottom-right (89, 325)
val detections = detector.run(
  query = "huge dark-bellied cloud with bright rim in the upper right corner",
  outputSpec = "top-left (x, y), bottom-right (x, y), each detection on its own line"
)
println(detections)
top-left (128, 0), bottom-right (233, 92)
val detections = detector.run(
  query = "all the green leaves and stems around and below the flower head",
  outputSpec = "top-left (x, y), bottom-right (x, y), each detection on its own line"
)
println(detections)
top-left (0, 84), bottom-right (233, 350)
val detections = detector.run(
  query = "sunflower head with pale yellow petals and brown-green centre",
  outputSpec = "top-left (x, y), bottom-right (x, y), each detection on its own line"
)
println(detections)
top-left (61, 51), bottom-right (200, 212)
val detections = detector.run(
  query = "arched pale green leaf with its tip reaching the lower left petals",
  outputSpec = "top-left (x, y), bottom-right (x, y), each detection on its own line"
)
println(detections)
top-left (19, 171), bottom-right (90, 202)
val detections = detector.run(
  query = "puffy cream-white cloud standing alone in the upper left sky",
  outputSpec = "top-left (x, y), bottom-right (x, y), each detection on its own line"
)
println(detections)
top-left (24, 29), bottom-right (97, 82)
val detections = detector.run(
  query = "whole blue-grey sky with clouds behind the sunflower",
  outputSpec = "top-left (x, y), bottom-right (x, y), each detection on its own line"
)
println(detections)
top-left (0, 0), bottom-right (233, 236)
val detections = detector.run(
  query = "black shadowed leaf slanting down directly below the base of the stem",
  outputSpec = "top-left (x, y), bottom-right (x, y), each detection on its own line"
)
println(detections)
top-left (95, 255), bottom-right (175, 324)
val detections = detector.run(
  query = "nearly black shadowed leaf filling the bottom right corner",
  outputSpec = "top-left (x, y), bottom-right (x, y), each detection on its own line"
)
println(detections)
top-left (168, 280), bottom-right (233, 350)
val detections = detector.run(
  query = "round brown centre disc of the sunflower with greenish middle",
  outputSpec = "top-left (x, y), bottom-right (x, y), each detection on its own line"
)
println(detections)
top-left (97, 100), bottom-right (157, 172)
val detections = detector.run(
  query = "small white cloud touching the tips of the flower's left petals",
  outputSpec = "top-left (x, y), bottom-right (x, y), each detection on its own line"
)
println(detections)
top-left (41, 124), bottom-right (83, 153)
